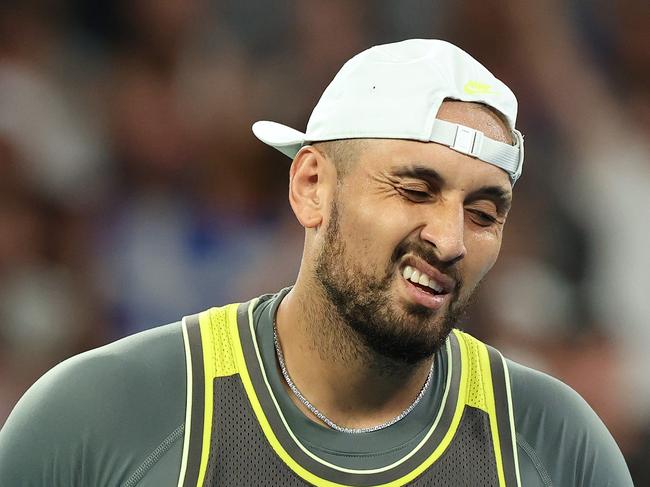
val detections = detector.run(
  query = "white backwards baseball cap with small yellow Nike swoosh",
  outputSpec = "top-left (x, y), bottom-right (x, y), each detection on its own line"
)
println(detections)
top-left (253, 39), bottom-right (524, 185)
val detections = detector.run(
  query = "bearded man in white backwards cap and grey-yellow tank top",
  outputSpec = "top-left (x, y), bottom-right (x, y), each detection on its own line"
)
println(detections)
top-left (0, 40), bottom-right (632, 486)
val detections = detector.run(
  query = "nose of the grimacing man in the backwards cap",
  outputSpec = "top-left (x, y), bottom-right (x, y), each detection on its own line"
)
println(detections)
top-left (420, 202), bottom-right (467, 264)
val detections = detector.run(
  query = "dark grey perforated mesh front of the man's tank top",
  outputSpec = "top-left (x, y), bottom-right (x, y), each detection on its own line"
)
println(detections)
top-left (205, 376), bottom-right (498, 487)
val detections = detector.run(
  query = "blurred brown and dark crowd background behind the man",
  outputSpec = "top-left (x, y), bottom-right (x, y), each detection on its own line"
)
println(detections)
top-left (0, 0), bottom-right (650, 485)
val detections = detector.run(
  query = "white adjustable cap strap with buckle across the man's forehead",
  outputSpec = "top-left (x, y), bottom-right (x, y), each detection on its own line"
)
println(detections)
top-left (429, 119), bottom-right (523, 184)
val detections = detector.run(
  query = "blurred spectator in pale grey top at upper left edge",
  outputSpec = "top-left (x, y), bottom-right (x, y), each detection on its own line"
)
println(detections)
top-left (0, 4), bottom-right (109, 210)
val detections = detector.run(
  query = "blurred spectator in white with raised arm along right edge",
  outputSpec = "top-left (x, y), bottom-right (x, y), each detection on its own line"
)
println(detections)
top-left (496, 2), bottom-right (650, 420)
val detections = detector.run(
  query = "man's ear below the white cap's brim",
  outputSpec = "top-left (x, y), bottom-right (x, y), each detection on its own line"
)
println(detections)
top-left (289, 145), bottom-right (336, 228)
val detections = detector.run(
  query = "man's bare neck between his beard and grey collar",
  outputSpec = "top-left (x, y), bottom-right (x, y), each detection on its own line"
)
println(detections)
top-left (276, 279), bottom-right (432, 428)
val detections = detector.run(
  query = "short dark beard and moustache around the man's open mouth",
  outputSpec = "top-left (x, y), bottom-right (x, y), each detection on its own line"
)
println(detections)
top-left (315, 200), bottom-right (474, 366)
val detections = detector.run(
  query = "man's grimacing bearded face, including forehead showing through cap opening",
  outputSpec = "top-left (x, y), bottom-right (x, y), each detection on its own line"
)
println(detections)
top-left (315, 102), bottom-right (511, 363)
